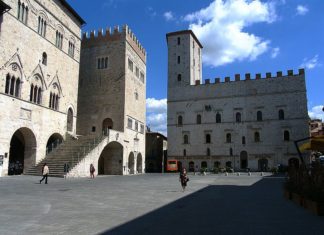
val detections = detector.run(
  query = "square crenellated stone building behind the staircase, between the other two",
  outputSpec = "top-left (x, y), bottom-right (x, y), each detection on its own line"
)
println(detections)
top-left (77, 25), bottom-right (146, 174)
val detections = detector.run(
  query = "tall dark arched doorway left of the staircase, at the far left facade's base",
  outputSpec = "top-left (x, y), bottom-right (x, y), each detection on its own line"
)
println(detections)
top-left (8, 127), bottom-right (37, 175)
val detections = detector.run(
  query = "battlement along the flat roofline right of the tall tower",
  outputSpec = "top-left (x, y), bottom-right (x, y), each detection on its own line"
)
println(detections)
top-left (195, 69), bottom-right (305, 85)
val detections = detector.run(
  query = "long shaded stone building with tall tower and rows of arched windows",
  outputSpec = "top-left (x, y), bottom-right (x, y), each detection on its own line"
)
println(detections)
top-left (167, 30), bottom-right (309, 171)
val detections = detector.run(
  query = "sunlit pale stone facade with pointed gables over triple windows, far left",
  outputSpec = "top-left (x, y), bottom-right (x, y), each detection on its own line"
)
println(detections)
top-left (0, 0), bottom-right (84, 175)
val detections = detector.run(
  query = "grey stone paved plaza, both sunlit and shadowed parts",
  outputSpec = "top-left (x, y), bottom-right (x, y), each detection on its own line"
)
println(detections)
top-left (0, 173), bottom-right (324, 235)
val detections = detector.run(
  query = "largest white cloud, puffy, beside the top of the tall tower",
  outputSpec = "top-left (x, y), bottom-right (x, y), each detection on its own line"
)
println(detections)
top-left (183, 0), bottom-right (277, 66)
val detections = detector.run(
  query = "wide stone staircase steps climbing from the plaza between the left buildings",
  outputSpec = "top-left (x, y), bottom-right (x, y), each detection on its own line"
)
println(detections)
top-left (24, 135), bottom-right (105, 177)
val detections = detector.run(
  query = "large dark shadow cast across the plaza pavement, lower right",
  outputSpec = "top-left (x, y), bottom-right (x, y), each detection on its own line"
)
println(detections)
top-left (101, 177), bottom-right (324, 235)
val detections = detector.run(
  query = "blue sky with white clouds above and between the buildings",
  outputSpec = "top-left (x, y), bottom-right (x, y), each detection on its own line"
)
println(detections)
top-left (68, 0), bottom-right (324, 134)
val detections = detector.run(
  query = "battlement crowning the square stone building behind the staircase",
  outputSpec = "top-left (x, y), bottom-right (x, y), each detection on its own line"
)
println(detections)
top-left (82, 25), bottom-right (146, 62)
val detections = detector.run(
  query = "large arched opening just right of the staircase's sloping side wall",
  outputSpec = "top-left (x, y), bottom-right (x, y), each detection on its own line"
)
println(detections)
top-left (98, 141), bottom-right (123, 175)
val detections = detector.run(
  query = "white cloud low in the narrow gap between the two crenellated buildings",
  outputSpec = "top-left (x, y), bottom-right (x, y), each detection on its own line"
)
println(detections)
top-left (146, 98), bottom-right (167, 136)
